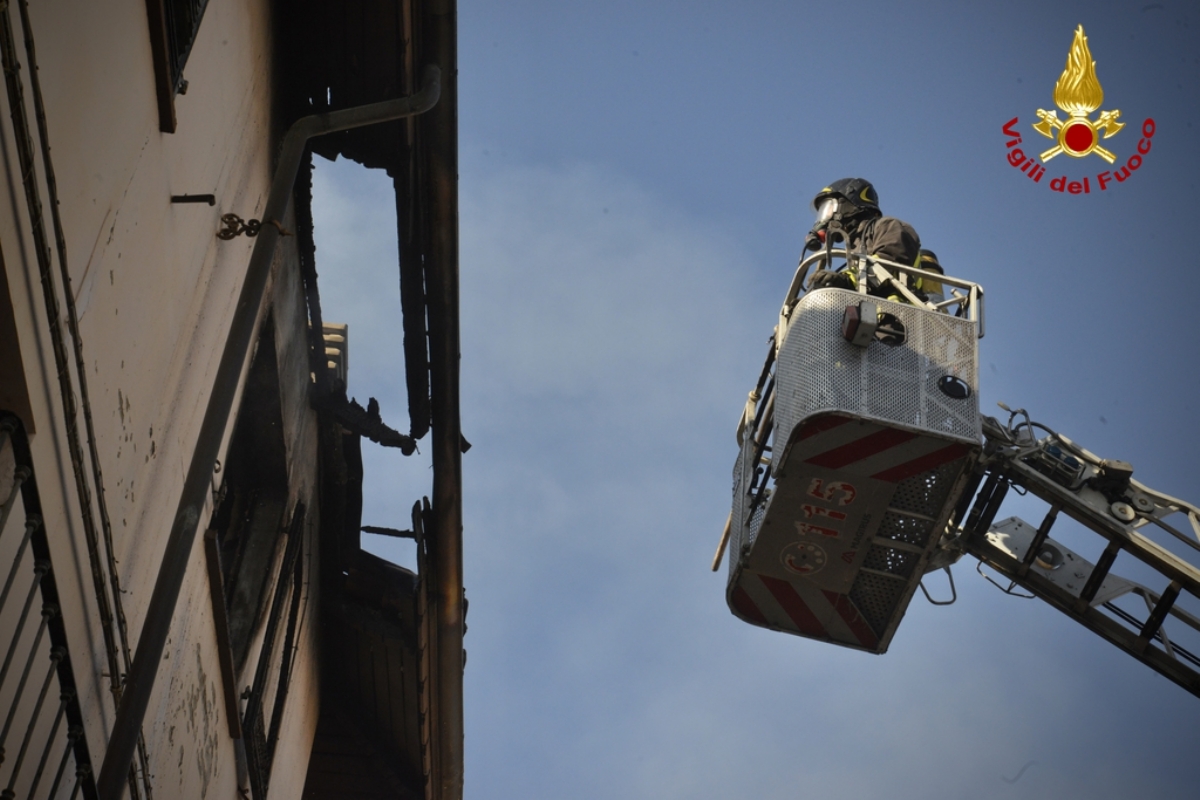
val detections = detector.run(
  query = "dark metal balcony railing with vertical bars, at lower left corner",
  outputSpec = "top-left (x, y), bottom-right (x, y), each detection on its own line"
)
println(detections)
top-left (0, 411), bottom-right (96, 800)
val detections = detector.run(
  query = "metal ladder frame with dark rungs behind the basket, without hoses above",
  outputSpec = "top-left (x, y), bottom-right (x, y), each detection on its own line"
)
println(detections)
top-left (961, 451), bottom-right (1200, 697)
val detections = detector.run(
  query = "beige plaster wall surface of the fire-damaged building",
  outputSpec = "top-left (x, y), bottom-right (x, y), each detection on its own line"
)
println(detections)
top-left (0, 0), bottom-right (318, 798)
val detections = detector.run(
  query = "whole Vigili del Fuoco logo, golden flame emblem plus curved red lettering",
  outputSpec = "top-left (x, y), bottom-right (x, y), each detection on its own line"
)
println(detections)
top-left (1003, 25), bottom-right (1154, 194)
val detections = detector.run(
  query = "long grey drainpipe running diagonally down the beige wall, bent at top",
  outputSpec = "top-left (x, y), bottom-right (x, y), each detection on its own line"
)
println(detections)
top-left (96, 65), bottom-right (442, 800)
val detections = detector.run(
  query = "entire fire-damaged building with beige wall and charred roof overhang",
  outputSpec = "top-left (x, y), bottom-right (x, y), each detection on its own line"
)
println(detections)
top-left (0, 0), bottom-right (464, 800)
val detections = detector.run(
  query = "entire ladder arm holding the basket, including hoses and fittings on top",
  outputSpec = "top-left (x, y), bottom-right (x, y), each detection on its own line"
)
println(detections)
top-left (943, 410), bottom-right (1200, 696)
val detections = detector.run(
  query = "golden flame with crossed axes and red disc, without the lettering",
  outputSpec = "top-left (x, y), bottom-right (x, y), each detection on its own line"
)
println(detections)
top-left (1033, 25), bottom-right (1124, 164)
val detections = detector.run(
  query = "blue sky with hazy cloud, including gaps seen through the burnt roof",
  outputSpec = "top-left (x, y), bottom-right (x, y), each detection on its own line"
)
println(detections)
top-left (316, 1), bottom-right (1200, 799)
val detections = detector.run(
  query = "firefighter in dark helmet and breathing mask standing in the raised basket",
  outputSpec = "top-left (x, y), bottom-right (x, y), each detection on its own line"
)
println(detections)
top-left (804, 178), bottom-right (920, 296)
